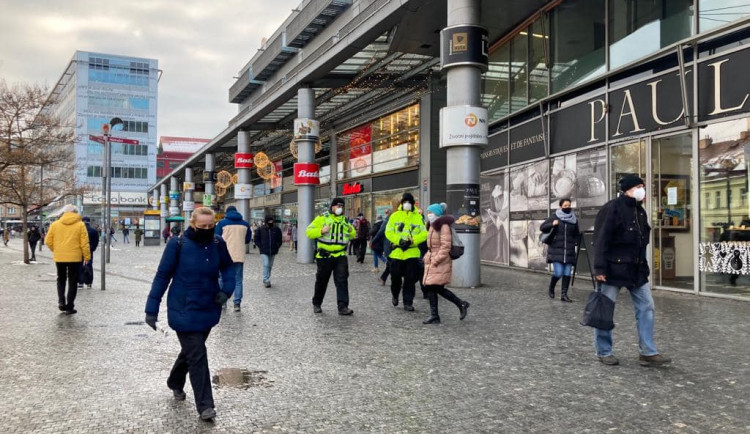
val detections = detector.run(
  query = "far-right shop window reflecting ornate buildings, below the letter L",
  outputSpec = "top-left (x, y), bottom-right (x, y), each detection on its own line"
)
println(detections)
top-left (698, 118), bottom-right (750, 297)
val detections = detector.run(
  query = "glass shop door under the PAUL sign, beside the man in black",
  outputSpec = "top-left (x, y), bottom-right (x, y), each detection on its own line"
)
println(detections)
top-left (644, 133), bottom-right (695, 291)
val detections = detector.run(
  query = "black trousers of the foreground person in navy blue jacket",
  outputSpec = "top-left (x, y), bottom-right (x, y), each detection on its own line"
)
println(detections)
top-left (167, 329), bottom-right (214, 413)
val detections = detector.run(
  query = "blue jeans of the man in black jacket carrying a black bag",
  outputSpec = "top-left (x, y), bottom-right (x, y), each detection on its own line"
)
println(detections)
top-left (594, 282), bottom-right (659, 357)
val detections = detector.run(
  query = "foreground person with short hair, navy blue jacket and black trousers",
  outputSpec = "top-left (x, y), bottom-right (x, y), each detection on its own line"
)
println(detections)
top-left (146, 208), bottom-right (235, 420)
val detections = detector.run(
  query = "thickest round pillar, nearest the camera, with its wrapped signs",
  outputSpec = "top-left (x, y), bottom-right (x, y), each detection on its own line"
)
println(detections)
top-left (441, 0), bottom-right (487, 287)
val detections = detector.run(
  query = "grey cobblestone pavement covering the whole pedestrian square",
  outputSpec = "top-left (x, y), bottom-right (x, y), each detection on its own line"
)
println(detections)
top-left (0, 240), bottom-right (750, 433)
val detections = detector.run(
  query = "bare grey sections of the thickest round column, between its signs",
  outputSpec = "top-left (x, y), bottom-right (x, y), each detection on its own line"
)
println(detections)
top-left (446, 0), bottom-right (482, 287)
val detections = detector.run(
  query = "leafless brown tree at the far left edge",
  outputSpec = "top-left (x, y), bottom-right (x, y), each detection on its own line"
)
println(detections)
top-left (0, 79), bottom-right (81, 264)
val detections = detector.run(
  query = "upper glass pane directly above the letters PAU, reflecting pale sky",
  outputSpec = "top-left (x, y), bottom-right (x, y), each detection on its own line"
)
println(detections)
top-left (609, 0), bottom-right (693, 69)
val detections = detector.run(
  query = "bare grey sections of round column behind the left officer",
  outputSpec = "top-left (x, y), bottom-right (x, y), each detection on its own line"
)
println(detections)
top-left (297, 88), bottom-right (315, 264)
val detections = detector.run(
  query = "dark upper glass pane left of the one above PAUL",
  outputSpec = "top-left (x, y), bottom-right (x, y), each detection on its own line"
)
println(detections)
top-left (550, 0), bottom-right (606, 93)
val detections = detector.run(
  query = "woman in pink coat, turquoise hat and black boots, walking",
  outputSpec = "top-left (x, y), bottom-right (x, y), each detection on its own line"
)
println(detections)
top-left (422, 203), bottom-right (469, 324)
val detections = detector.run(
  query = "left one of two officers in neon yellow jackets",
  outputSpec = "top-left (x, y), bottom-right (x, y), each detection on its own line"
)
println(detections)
top-left (305, 197), bottom-right (356, 315)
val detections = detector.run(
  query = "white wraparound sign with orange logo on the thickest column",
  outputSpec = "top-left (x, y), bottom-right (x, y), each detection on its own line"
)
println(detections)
top-left (440, 106), bottom-right (488, 148)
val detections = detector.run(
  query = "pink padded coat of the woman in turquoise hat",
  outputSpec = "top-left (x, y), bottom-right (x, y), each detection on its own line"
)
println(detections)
top-left (422, 215), bottom-right (455, 285)
